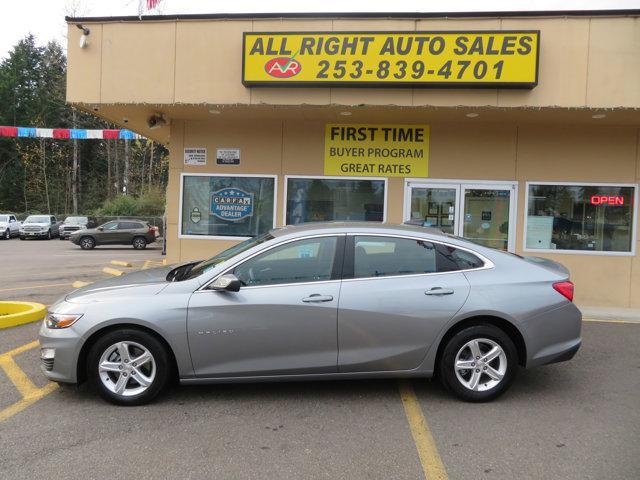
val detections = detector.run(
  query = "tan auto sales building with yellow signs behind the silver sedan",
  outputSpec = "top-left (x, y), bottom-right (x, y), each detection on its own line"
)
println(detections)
top-left (67, 11), bottom-right (640, 307)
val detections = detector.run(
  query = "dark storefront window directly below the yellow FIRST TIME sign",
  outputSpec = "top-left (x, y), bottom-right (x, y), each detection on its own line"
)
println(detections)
top-left (286, 177), bottom-right (386, 225)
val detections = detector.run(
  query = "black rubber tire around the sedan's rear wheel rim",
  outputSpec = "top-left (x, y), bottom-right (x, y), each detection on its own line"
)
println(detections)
top-left (437, 324), bottom-right (518, 402)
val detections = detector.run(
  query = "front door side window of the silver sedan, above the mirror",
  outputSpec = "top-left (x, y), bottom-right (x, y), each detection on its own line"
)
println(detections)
top-left (233, 237), bottom-right (338, 287)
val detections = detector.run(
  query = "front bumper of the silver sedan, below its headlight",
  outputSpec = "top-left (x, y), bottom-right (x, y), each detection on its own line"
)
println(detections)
top-left (38, 322), bottom-right (83, 383)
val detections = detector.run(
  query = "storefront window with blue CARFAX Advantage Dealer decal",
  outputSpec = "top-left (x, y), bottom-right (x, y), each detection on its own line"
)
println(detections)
top-left (180, 175), bottom-right (276, 237)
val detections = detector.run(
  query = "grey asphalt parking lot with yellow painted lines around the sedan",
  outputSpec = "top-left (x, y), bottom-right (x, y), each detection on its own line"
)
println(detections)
top-left (0, 240), bottom-right (640, 479)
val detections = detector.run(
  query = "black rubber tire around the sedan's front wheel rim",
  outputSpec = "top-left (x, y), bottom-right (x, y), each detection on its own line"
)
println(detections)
top-left (87, 328), bottom-right (172, 406)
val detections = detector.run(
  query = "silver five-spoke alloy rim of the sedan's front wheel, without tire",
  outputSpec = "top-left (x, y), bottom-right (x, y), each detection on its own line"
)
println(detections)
top-left (98, 341), bottom-right (156, 397)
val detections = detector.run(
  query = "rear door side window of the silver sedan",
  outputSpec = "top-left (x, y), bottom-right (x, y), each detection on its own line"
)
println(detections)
top-left (353, 236), bottom-right (436, 278)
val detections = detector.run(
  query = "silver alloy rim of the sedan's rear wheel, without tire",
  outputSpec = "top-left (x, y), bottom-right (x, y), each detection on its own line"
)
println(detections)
top-left (454, 338), bottom-right (507, 392)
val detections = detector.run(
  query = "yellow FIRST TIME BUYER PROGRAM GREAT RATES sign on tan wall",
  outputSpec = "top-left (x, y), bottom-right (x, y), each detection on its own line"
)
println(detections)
top-left (324, 124), bottom-right (429, 177)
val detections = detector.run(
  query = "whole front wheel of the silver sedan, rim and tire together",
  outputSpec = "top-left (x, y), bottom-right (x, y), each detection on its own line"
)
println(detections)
top-left (87, 329), bottom-right (171, 405)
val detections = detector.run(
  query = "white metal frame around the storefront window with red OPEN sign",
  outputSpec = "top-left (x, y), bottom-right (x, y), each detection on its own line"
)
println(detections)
top-left (522, 180), bottom-right (638, 257)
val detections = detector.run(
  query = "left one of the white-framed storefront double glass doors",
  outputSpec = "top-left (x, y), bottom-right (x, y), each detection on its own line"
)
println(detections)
top-left (405, 184), bottom-right (460, 235)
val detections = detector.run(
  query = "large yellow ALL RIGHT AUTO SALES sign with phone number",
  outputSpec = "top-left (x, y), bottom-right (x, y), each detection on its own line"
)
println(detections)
top-left (242, 30), bottom-right (540, 88)
